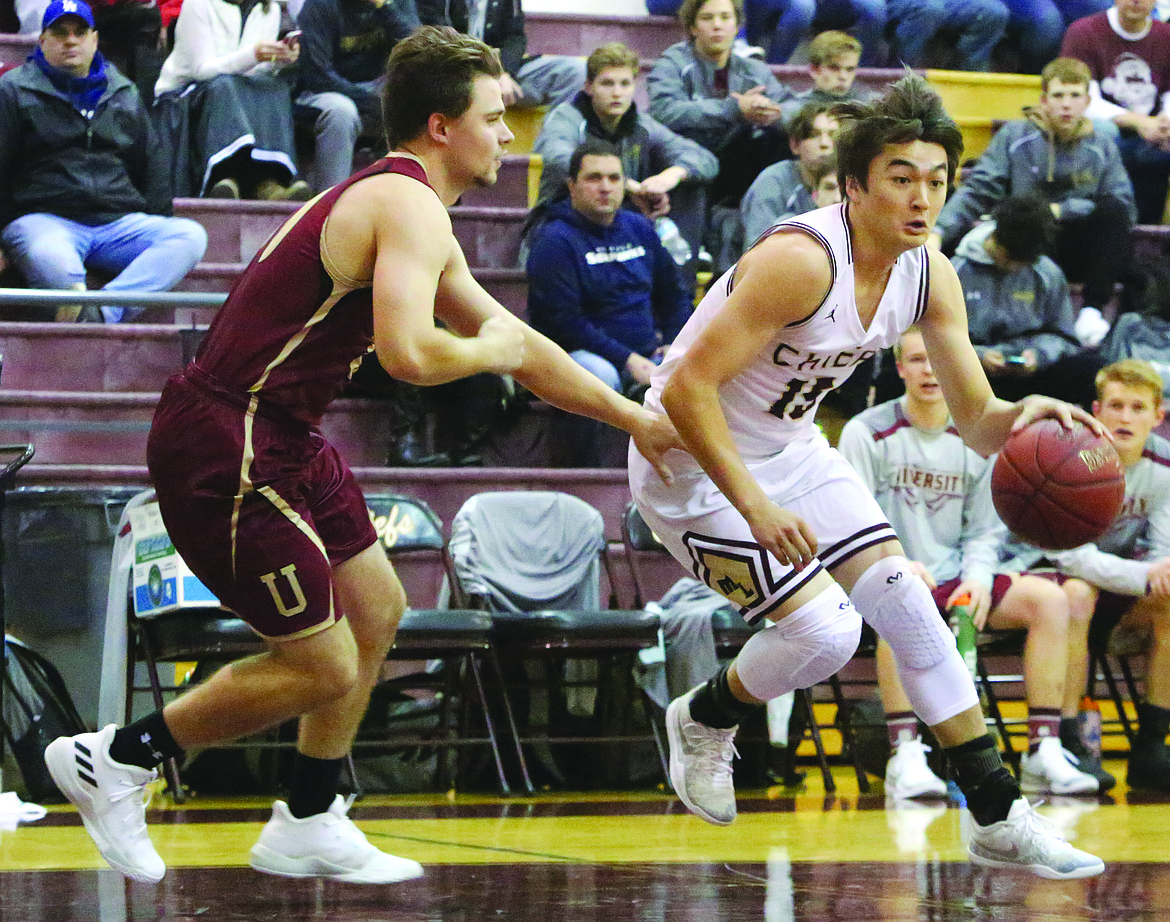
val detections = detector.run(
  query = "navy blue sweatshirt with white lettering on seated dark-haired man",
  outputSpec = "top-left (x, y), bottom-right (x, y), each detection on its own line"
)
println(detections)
top-left (528, 201), bottom-right (691, 372)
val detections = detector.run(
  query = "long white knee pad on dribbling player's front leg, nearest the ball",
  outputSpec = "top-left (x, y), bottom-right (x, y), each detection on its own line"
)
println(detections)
top-left (853, 557), bottom-right (979, 727)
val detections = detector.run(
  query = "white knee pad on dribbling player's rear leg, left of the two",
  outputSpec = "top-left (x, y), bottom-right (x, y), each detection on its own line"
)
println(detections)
top-left (736, 584), bottom-right (861, 701)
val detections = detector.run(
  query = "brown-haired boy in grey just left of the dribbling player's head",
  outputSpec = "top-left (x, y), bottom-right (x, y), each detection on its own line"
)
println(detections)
top-left (739, 102), bottom-right (837, 243)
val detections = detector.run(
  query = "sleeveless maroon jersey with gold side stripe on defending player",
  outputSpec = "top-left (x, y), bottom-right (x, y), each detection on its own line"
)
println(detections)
top-left (194, 156), bottom-right (429, 425)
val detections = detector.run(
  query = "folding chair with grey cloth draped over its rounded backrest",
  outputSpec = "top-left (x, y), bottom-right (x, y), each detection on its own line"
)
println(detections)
top-left (449, 491), bottom-right (667, 791)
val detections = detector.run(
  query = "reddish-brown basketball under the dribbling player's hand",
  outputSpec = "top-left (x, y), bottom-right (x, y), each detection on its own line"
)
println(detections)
top-left (991, 419), bottom-right (1126, 551)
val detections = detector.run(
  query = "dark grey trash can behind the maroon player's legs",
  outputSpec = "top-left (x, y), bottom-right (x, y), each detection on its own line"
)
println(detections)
top-left (2, 487), bottom-right (142, 727)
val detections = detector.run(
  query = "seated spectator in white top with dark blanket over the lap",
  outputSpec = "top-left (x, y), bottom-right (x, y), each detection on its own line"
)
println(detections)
top-left (154, 0), bottom-right (312, 201)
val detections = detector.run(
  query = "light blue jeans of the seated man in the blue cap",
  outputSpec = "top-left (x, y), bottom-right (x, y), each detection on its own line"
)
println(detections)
top-left (0, 213), bottom-right (207, 323)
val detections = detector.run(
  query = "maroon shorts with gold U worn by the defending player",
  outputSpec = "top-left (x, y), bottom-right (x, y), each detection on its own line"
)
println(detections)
top-left (146, 372), bottom-right (377, 640)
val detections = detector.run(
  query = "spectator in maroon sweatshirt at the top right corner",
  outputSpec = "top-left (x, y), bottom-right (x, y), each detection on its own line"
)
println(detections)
top-left (1060, 0), bottom-right (1170, 224)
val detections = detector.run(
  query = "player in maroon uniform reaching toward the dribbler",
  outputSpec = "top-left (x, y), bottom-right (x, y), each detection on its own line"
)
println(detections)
top-left (47, 27), bottom-right (680, 883)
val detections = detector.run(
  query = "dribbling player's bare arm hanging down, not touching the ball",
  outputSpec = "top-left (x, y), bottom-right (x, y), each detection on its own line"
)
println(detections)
top-left (662, 233), bottom-right (832, 569)
